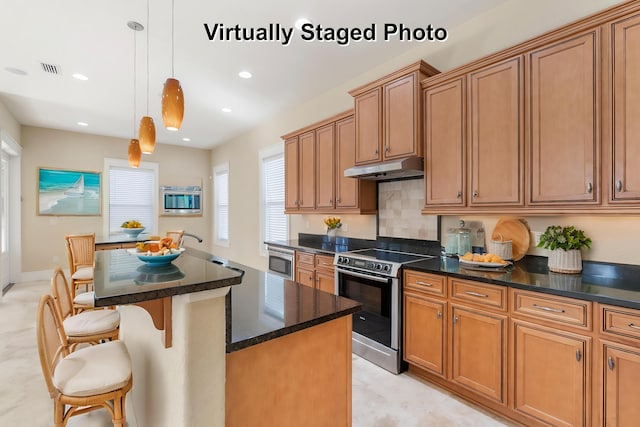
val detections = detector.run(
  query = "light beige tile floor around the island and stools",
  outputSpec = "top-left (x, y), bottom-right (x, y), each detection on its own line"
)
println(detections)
top-left (0, 281), bottom-right (513, 427)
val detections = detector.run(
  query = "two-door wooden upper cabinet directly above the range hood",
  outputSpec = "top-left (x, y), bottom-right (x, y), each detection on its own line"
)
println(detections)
top-left (349, 61), bottom-right (438, 165)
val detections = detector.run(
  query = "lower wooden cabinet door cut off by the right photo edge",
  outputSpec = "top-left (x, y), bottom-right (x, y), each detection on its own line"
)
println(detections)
top-left (602, 344), bottom-right (640, 427)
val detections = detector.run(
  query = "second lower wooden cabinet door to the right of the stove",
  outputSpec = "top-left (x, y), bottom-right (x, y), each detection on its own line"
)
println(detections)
top-left (451, 305), bottom-right (507, 403)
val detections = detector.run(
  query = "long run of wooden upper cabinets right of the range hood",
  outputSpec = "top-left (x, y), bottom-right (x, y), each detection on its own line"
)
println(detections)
top-left (422, 2), bottom-right (640, 214)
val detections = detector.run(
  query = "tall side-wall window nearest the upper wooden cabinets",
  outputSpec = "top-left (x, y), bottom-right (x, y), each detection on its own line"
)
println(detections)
top-left (260, 144), bottom-right (289, 255)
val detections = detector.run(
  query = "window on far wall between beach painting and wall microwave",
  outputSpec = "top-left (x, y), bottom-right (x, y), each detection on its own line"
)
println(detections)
top-left (104, 159), bottom-right (158, 234)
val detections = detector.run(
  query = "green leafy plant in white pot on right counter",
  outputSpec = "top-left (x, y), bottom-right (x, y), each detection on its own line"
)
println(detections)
top-left (538, 225), bottom-right (591, 273)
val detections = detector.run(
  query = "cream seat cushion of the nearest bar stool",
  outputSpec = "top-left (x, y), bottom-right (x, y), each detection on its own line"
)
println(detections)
top-left (53, 342), bottom-right (131, 397)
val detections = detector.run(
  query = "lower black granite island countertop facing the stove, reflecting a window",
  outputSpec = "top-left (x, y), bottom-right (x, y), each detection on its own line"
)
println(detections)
top-left (225, 259), bottom-right (361, 353)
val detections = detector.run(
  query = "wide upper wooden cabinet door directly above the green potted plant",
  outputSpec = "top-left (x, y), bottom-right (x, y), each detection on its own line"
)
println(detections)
top-left (528, 30), bottom-right (600, 204)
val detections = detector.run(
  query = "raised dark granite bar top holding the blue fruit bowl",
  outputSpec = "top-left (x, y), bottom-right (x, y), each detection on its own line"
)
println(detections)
top-left (94, 248), bottom-right (243, 307)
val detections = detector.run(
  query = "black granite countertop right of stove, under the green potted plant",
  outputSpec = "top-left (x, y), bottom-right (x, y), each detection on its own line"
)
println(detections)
top-left (405, 255), bottom-right (640, 309)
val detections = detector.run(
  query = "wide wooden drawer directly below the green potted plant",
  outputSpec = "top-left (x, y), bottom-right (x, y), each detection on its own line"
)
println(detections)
top-left (511, 288), bottom-right (592, 332)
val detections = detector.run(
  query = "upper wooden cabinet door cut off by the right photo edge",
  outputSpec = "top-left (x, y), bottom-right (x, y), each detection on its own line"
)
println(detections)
top-left (607, 15), bottom-right (640, 201)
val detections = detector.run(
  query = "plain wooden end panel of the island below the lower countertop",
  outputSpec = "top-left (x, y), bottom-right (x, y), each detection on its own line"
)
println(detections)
top-left (225, 316), bottom-right (352, 427)
